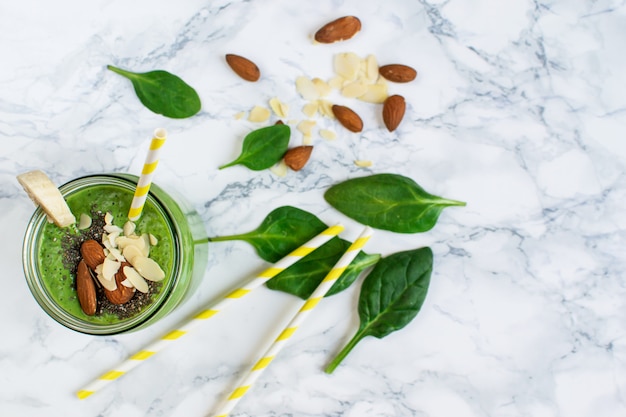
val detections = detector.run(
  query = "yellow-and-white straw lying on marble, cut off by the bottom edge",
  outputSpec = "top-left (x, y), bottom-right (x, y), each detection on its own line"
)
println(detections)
top-left (213, 226), bottom-right (372, 417)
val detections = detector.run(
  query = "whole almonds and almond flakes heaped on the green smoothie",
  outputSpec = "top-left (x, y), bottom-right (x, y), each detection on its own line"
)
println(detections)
top-left (76, 213), bottom-right (165, 315)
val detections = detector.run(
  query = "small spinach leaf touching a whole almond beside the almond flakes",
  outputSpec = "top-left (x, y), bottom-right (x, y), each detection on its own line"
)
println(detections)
top-left (219, 124), bottom-right (291, 171)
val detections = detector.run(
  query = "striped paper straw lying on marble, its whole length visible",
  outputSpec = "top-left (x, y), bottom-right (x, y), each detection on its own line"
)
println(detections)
top-left (76, 224), bottom-right (344, 399)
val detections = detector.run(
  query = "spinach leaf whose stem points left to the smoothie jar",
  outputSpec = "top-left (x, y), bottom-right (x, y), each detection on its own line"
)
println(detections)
top-left (209, 206), bottom-right (327, 263)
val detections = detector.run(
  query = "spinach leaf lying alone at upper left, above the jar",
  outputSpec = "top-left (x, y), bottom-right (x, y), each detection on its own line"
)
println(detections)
top-left (107, 65), bottom-right (201, 119)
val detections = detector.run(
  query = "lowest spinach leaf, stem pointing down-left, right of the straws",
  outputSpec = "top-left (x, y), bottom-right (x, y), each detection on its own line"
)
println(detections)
top-left (325, 247), bottom-right (433, 373)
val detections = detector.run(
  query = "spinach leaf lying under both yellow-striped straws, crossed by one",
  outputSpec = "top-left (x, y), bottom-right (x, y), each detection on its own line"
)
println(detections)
top-left (266, 237), bottom-right (380, 300)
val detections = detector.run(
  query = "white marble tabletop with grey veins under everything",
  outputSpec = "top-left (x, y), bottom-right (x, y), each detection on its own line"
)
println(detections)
top-left (0, 0), bottom-right (626, 417)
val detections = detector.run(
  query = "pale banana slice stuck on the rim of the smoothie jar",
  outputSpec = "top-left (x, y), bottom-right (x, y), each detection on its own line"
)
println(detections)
top-left (17, 170), bottom-right (76, 227)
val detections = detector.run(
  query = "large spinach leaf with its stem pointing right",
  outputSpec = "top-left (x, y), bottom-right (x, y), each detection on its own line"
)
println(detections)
top-left (324, 174), bottom-right (465, 233)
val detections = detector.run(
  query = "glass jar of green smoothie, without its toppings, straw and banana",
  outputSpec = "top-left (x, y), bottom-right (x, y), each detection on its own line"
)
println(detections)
top-left (22, 174), bottom-right (208, 335)
